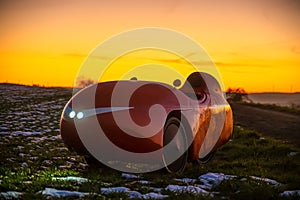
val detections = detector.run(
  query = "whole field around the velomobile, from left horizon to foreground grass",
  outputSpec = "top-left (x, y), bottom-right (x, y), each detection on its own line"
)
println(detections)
top-left (0, 86), bottom-right (300, 199)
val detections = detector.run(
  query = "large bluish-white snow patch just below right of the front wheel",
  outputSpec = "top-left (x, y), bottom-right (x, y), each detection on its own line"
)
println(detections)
top-left (199, 172), bottom-right (236, 189)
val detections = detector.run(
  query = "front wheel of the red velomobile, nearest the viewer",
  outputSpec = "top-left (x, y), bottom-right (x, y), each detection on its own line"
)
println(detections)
top-left (163, 117), bottom-right (188, 173)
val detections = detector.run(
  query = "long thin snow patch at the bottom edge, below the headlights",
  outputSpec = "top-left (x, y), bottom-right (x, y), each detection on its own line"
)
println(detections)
top-left (38, 188), bottom-right (89, 198)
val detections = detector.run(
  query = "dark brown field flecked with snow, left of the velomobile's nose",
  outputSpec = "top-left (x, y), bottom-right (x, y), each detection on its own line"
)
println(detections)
top-left (0, 84), bottom-right (72, 136)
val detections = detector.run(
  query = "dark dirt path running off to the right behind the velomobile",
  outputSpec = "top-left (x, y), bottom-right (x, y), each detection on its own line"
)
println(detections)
top-left (231, 103), bottom-right (300, 148)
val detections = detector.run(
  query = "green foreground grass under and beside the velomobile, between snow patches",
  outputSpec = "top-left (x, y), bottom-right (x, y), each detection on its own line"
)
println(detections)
top-left (0, 125), bottom-right (300, 199)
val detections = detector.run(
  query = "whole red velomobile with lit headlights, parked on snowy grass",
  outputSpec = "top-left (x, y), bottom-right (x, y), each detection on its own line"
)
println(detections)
top-left (60, 72), bottom-right (233, 172)
